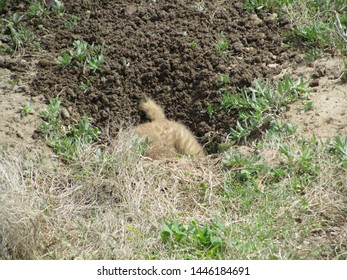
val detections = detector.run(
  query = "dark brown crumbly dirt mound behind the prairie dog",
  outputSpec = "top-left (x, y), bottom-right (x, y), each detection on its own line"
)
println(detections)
top-left (31, 0), bottom-right (290, 150)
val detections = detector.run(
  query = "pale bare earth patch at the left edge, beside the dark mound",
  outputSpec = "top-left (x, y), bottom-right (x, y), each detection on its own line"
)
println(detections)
top-left (0, 56), bottom-right (51, 159)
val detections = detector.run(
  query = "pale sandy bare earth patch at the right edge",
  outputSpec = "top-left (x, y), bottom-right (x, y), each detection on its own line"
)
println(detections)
top-left (281, 57), bottom-right (347, 140)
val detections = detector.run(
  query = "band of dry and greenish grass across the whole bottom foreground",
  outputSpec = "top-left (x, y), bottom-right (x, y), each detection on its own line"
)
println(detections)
top-left (0, 128), bottom-right (347, 259)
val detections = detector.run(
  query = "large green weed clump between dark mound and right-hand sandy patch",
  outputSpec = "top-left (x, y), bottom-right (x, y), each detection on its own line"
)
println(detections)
top-left (220, 76), bottom-right (309, 141)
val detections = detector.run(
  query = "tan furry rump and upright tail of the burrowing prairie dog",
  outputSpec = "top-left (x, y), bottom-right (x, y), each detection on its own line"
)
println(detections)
top-left (135, 99), bottom-right (205, 159)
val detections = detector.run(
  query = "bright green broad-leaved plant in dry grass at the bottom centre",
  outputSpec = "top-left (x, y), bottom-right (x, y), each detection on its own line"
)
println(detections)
top-left (160, 221), bottom-right (224, 259)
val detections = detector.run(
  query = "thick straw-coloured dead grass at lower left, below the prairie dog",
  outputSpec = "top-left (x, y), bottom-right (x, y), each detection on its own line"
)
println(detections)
top-left (0, 129), bottom-right (223, 259)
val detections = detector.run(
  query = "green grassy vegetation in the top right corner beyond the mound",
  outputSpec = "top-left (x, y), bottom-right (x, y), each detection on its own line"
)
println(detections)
top-left (245, 0), bottom-right (347, 56)
